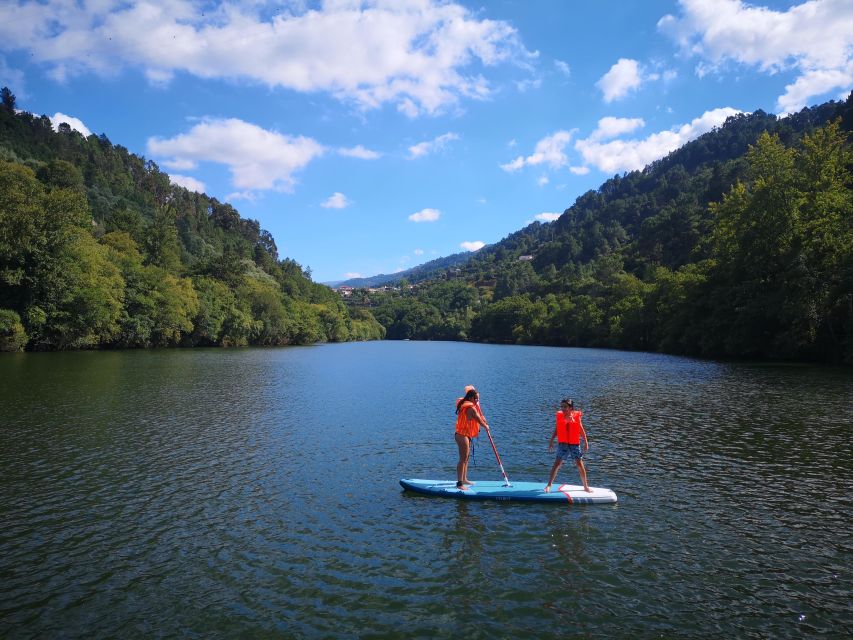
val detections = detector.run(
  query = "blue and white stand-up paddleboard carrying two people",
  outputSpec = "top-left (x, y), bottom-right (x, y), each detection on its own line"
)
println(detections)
top-left (400, 479), bottom-right (616, 504)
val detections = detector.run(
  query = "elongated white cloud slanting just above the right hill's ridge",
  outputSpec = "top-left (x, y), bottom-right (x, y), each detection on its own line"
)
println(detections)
top-left (575, 107), bottom-right (741, 173)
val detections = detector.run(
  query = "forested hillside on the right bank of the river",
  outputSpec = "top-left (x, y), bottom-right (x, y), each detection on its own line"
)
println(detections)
top-left (364, 94), bottom-right (853, 364)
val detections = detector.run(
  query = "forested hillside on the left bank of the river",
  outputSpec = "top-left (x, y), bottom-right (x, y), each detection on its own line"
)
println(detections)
top-left (0, 88), bottom-right (385, 351)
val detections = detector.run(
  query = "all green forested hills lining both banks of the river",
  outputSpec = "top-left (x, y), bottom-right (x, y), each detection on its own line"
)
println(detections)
top-left (0, 87), bottom-right (853, 365)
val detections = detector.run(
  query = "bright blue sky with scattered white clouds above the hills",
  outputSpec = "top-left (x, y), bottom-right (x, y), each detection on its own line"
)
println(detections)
top-left (0, 0), bottom-right (853, 282)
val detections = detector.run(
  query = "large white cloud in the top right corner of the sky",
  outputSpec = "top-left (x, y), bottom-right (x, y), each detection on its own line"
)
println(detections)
top-left (658, 0), bottom-right (853, 113)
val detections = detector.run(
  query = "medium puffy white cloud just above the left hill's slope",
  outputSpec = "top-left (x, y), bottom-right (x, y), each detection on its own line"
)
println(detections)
top-left (147, 118), bottom-right (325, 191)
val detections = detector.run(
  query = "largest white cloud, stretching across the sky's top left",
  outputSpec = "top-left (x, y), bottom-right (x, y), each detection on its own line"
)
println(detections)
top-left (0, 0), bottom-right (537, 116)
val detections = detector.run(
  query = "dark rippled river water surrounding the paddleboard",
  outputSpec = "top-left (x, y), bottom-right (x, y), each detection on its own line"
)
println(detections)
top-left (0, 342), bottom-right (853, 638)
